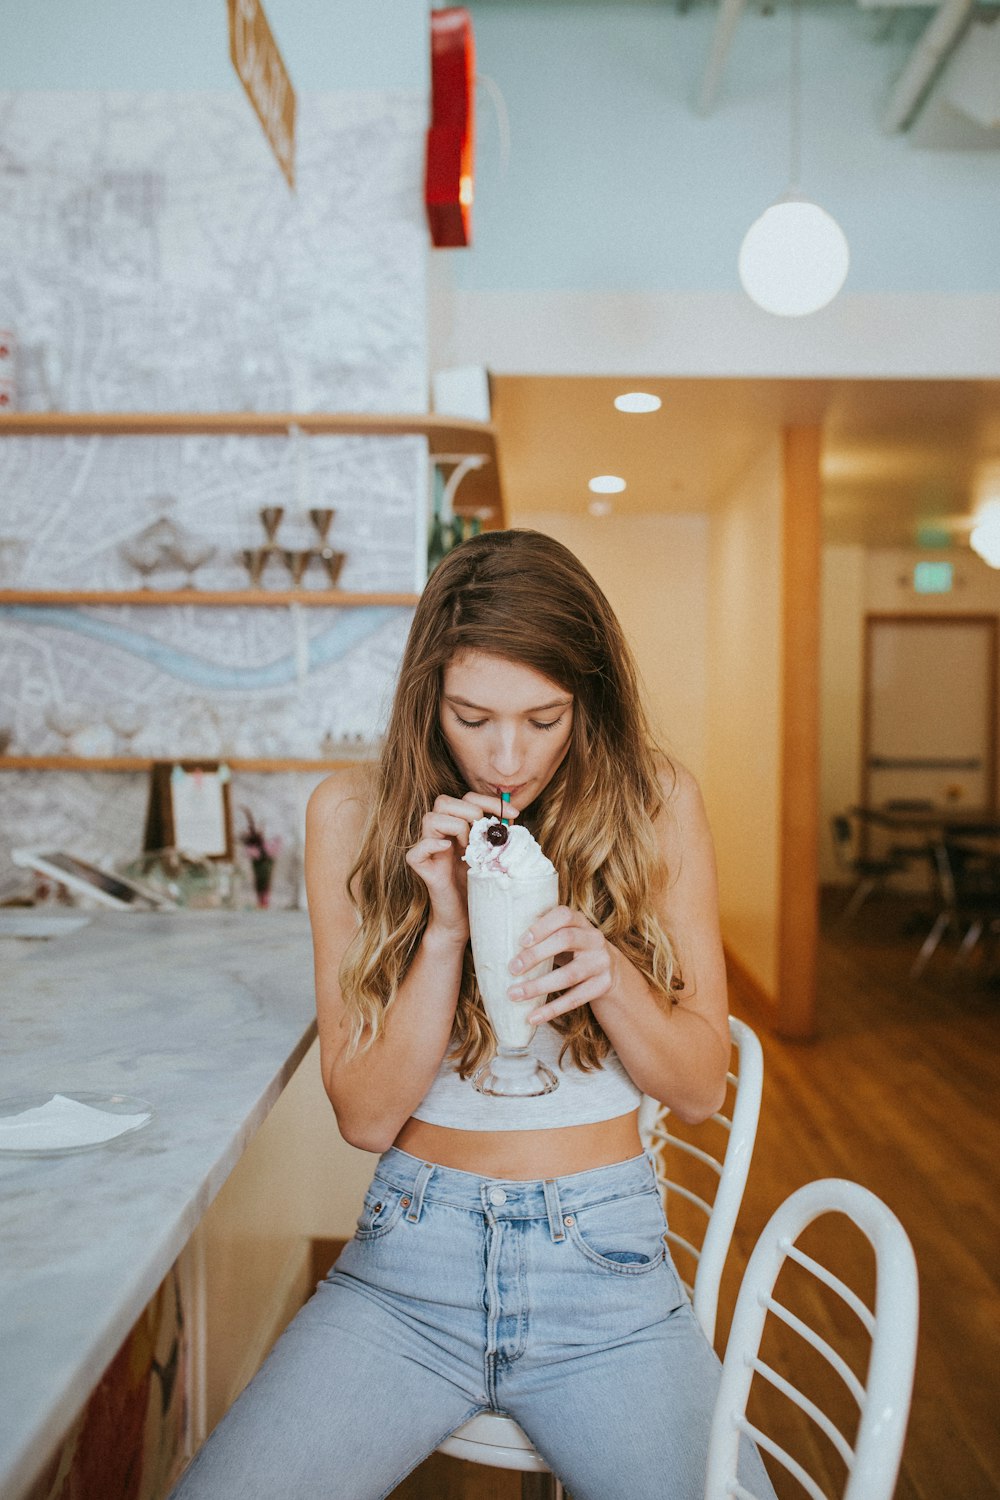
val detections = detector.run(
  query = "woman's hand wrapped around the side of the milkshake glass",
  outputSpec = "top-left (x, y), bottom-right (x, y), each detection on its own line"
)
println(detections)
top-left (508, 906), bottom-right (621, 1025)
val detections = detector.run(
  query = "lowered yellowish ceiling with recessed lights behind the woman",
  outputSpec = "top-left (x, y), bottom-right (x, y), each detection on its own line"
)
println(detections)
top-left (492, 375), bottom-right (1000, 546)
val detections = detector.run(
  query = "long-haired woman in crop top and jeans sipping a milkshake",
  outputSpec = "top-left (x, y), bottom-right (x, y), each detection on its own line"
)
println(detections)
top-left (170, 531), bottom-right (772, 1500)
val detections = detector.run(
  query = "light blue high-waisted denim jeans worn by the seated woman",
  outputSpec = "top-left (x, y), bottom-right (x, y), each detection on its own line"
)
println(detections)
top-left (172, 1148), bottom-right (774, 1500)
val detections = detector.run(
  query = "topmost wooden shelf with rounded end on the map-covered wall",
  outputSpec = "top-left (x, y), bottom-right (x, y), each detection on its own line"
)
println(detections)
top-left (0, 411), bottom-right (505, 527)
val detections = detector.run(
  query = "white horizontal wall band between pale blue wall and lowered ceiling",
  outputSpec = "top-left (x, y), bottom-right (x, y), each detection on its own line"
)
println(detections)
top-left (430, 286), bottom-right (1000, 380)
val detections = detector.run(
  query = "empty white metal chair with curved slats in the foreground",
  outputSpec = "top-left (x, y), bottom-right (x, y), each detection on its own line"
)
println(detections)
top-left (705, 1178), bottom-right (918, 1500)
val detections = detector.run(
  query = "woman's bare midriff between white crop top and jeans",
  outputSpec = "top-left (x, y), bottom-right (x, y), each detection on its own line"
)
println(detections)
top-left (393, 1110), bottom-right (642, 1182)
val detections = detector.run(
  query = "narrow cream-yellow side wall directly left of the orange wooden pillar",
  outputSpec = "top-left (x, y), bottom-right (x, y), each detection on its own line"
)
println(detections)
top-left (705, 434), bottom-right (783, 996)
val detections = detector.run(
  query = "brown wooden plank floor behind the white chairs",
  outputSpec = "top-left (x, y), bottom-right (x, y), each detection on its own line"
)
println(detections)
top-left (352, 900), bottom-right (1000, 1500)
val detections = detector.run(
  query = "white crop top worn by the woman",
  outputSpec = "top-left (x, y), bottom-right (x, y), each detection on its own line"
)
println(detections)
top-left (414, 1025), bottom-right (642, 1130)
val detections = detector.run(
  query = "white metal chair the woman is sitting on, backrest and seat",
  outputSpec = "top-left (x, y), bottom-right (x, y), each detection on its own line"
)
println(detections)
top-left (438, 1016), bottom-right (763, 1500)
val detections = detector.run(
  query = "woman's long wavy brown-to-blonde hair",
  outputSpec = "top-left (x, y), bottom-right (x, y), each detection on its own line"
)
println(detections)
top-left (340, 531), bottom-right (675, 1077)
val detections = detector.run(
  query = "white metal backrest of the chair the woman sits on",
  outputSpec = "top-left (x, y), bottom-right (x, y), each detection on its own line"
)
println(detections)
top-left (639, 1016), bottom-right (763, 1344)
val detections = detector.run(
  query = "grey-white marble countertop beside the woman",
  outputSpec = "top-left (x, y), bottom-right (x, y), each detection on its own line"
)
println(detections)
top-left (0, 912), bottom-right (316, 1500)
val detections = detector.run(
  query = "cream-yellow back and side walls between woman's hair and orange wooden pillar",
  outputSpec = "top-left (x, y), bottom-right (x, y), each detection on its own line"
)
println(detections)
top-left (521, 462), bottom-right (783, 995)
